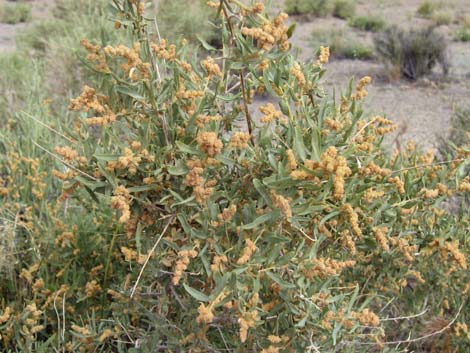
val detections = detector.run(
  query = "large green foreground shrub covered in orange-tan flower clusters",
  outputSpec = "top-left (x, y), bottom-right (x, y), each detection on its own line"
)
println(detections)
top-left (0, 0), bottom-right (470, 353)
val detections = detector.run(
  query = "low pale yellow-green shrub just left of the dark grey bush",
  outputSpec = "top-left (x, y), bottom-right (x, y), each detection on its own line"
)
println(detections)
top-left (312, 30), bottom-right (374, 60)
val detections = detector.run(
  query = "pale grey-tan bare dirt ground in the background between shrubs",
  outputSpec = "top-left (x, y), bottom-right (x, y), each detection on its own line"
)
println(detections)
top-left (0, 0), bottom-right (470, 147)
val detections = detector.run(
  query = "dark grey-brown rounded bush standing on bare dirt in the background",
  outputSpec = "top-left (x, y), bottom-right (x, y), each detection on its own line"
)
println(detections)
top-left (374, 26), bottom-right (449, 80)
